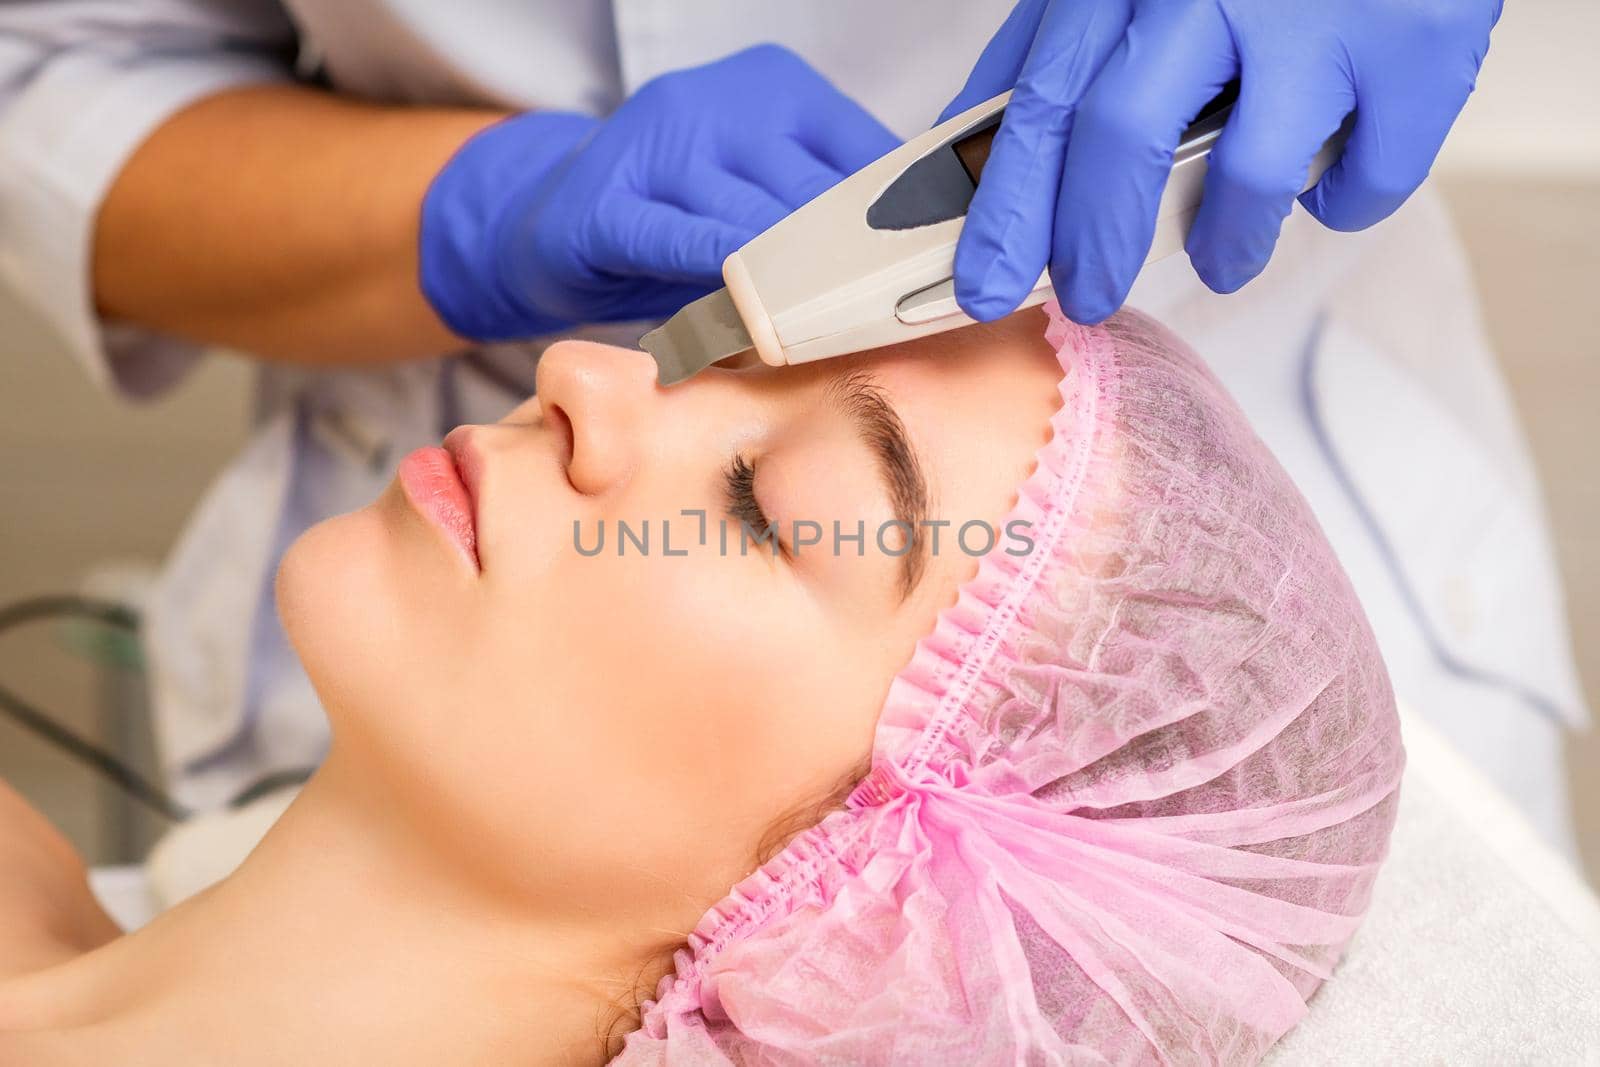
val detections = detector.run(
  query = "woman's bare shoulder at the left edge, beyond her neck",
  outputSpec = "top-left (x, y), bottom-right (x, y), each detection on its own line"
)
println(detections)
top-left (0, 781), bottom-right (122, 979)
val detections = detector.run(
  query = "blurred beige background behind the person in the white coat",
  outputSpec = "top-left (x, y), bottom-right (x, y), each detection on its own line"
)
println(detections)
top-left (0, 0), bottom-right (1600, 886)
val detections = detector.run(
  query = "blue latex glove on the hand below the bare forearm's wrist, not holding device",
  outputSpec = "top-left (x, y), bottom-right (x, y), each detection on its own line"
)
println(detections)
top-left (421, 45), bottom-right (899, 341)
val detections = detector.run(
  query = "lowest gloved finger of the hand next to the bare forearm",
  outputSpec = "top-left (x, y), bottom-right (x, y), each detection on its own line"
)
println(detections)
top-left (589, 197), bottom-right (755, 281)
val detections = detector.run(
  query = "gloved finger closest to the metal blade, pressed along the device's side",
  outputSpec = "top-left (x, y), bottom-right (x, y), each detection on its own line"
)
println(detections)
top-left (955, 0), bottom-right (1131, 322)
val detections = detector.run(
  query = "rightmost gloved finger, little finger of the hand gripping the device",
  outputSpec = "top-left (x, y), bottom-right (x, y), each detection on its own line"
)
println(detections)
top-left (1301, 60), bottom-right (1486, 230)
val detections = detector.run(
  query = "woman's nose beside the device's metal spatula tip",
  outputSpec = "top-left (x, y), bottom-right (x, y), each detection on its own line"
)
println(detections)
top-left (534, 341), bottom-right (656, 496)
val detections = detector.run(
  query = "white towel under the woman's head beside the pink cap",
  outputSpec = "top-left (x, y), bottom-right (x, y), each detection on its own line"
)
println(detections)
top-left (1266, 709), bottom-right (1600, 1067)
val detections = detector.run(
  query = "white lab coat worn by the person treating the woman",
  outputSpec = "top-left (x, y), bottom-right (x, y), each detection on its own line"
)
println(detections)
top-left (0, 0), bottom-right (1586, 851)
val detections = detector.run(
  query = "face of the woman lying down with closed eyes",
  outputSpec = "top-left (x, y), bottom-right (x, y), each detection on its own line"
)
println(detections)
top-left (278, 312), bottom-right (1061, 928)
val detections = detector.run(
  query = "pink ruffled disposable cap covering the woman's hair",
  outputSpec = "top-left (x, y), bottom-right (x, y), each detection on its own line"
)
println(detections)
top-left (619, 306), bottom-right (1403, 1064)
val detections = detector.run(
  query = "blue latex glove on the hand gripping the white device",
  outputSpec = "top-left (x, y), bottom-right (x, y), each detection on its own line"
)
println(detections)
top-left (946, 0), bottom-right (1501, 323)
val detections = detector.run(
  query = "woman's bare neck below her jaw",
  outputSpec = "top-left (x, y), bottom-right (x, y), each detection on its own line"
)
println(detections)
top-left (0, 749), bottom-right (642, 1064)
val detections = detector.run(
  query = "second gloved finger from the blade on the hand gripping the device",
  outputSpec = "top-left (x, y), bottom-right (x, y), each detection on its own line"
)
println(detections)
top-left (1050, 0), bottom-right (1238, 323)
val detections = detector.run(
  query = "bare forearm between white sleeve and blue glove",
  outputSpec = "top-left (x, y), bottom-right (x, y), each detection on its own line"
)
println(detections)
top-left (93, 86), bottom-right (501, 365)
